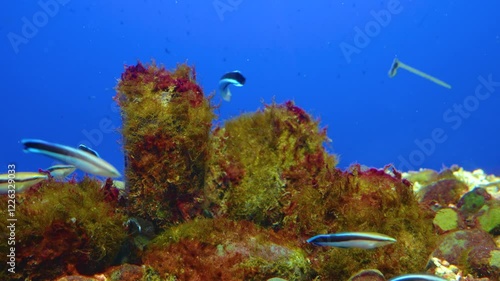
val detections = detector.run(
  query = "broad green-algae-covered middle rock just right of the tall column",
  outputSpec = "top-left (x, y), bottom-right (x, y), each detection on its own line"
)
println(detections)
top-left (205, 103), bottom-right (336, 227)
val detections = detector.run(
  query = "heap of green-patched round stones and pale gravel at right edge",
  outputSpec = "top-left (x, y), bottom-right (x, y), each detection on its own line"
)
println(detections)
top-left (404, 166), bottom-right (500, 280)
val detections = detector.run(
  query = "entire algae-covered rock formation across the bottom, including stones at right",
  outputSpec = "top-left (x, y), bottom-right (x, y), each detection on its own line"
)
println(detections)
top-left (9, 60), bottom-right (500, 280)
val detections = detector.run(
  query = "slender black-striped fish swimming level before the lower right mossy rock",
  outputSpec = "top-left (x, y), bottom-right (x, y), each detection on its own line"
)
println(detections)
top-left (307, 232), bottom-right (396, 249)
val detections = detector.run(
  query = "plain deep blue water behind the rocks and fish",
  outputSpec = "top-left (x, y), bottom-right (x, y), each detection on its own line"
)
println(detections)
top-left (0, 0), bottom-right (500, 177)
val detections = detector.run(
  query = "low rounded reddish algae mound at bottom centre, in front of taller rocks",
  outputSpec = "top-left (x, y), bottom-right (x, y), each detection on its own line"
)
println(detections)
top-left (144, 219), bottom-right (313, 280)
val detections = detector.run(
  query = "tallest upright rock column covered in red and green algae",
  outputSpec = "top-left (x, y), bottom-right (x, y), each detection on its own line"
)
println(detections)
top-left (115, 63), bottom-right (214, 227)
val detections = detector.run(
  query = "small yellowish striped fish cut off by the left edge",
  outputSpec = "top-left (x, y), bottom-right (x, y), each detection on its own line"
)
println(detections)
top-left (0, 172), bottom-right (49, 194)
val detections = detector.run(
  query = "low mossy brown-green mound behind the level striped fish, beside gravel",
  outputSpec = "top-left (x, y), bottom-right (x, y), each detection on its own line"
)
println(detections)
top-left (309, 165), bottom-right (437, 280)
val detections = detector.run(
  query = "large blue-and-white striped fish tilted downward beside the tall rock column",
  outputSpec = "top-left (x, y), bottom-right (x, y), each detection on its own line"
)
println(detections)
top-left (21, 139), bottom-right (121, 178)
